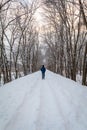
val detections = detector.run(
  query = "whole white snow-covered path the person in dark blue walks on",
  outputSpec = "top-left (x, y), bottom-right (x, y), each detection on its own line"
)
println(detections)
top-left (0, 70), bottom-right (87, 130)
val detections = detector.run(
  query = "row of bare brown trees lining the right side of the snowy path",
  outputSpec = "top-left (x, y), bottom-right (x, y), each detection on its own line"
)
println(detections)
top-left (43, 0), bottom-right (87, 85)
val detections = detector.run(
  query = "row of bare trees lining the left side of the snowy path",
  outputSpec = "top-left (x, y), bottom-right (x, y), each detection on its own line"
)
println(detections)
top-left (0, 0), bottom-right (40, 83)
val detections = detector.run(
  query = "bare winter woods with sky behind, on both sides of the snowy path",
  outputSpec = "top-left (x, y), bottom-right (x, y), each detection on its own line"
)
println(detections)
top-left (0, 0), bottom-right (87, 85)
